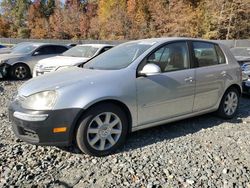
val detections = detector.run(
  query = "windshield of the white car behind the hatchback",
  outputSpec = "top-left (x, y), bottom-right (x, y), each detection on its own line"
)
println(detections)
top-left (62, 46), bottom-right (98, 58)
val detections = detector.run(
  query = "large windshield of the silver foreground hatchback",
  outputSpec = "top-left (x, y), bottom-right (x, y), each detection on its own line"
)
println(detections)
top-left (84, 42), bottom-right (155, 70)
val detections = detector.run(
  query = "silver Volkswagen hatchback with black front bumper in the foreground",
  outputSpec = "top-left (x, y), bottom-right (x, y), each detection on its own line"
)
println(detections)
top-left (9, 38), bottom-right (242, 156)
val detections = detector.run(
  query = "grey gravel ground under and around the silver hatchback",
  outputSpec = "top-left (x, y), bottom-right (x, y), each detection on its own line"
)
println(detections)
top-left (0, 81), bottom-right (250, 188)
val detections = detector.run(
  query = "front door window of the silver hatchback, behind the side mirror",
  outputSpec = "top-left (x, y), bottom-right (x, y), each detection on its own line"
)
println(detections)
top-left (139, 42), bottom-right (190, 72)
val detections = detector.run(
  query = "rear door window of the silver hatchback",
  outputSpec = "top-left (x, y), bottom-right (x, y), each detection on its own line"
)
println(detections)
top-left (193, 42), bottom-right (226, 67)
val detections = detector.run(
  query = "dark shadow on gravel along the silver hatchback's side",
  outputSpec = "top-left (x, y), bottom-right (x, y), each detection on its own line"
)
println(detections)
top-left (118, 95), bottom-right (250, 153)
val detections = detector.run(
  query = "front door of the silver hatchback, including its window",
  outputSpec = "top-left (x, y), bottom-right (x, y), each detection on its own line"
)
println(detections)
top-left (136, 42), bottom-right (195, 125)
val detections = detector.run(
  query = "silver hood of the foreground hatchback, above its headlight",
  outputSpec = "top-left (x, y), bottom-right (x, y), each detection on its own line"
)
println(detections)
top-left (18, 67), bottom-right (119, 96)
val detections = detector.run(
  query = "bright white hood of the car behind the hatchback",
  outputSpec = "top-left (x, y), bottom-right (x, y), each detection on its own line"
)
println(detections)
top-left (38, 56), bottom-right (89, 67)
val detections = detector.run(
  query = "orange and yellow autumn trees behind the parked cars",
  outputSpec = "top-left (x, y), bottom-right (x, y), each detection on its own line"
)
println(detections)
top-left (0, 0), bottom-right (250, 40)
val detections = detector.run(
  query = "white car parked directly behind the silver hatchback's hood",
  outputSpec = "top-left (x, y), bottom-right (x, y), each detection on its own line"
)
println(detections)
top-left (33, 44), bottom-right (114, 77)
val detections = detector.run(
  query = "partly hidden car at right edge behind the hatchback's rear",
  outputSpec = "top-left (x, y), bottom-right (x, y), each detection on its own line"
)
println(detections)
top-left (230, 47), bottom-right (250, 94)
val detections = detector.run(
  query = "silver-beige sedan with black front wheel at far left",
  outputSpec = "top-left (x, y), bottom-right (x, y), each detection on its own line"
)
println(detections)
top-left (0, 42), bottom-right (69, 80)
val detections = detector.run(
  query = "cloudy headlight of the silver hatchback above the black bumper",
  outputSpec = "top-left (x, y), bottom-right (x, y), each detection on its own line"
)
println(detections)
top-left (21, 91), bottom-right (57, 110)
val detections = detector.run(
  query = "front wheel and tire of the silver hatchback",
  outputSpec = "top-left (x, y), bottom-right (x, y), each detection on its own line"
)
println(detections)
top-left (76, 103), bottom-right (128, 157)
